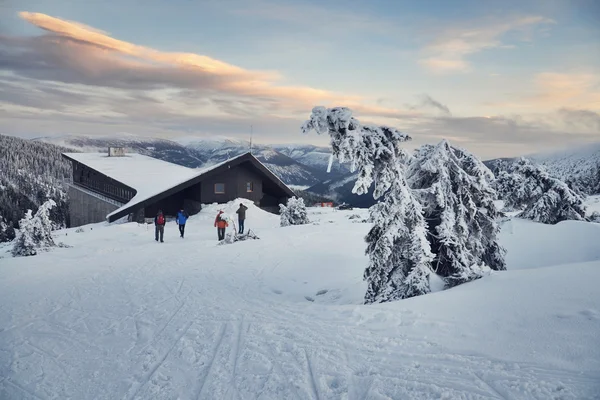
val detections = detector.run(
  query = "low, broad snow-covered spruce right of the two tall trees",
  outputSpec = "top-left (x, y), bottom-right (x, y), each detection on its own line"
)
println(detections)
top-left (497, 158), bottom-right (585, 224)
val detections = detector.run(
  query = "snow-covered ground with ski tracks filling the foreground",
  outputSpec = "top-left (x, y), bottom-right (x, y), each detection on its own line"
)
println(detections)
top-left (0, 202), bottom-right (600, 400)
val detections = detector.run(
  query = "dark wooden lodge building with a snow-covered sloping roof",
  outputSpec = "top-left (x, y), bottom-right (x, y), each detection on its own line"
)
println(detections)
top-left (63, 148), bottom-right (294, 227)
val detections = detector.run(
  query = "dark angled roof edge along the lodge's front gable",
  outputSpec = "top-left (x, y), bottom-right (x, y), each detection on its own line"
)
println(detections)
top-left (108, 152), bottom-right (295, 222)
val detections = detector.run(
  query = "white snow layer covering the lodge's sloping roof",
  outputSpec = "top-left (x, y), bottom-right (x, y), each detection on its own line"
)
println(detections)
top-left (63, 153), bottom-right (251, 218)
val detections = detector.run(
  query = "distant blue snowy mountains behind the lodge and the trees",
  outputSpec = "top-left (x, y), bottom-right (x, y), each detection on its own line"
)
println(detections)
top-left (35, 136), bottom-right (600, 207)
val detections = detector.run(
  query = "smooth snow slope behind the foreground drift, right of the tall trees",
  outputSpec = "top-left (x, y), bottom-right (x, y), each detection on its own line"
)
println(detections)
top-left (500, 218), bottom-right (600, 270)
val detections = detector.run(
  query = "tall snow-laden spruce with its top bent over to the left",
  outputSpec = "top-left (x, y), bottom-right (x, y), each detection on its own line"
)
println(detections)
top-left (302, 107), bottom-right (433, 304)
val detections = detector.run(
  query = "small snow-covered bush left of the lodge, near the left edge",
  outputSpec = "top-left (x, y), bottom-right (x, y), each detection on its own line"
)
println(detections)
top-left (12, 200), bottom-right (56, 257)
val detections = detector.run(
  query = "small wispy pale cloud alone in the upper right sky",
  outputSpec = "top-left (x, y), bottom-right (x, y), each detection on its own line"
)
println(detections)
top-left (419, 16), bottom-right (554, 73)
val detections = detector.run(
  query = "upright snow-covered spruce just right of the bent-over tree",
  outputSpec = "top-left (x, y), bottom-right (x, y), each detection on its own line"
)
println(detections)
top-left (407, 140), bottom-right (506, 287)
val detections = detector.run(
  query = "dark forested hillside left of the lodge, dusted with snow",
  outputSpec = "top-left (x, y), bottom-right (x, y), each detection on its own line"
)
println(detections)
top-left (0, 135), bottom-right (72, 241)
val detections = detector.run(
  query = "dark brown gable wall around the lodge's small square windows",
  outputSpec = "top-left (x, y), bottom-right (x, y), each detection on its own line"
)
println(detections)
top-left (201, 163), bottom-right (262, 205)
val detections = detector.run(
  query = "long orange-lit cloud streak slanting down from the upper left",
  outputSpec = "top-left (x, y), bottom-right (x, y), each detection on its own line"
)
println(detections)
top-left (0, 12), bottom-right (418, 120)
